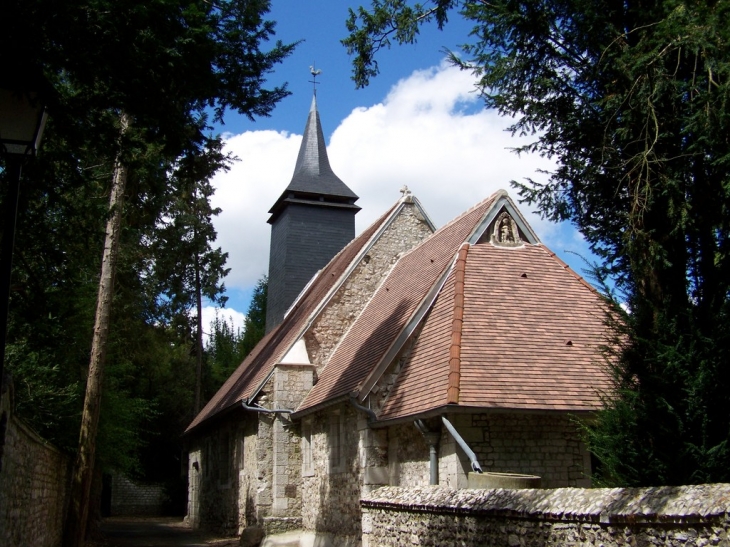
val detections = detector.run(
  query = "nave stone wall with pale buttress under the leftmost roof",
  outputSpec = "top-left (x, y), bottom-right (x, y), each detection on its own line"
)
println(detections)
top-left (187, 364), bottom-right (314, 536)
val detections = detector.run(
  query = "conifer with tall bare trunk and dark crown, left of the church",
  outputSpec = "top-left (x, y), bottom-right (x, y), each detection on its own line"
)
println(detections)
top-left (0, 0), bottom-right (293, 546)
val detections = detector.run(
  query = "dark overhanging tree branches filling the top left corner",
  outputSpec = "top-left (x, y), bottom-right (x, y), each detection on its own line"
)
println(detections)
top-left (0, 0), bottom-right (295, 156)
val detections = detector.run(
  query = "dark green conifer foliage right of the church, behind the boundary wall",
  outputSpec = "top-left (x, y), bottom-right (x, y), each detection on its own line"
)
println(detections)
top-left (344, 0), bottom-right (730, 484)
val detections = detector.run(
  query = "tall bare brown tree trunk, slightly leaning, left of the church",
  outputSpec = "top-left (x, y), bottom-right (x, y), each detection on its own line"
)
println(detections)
top-left (64, 112), bottom-right (130, 547)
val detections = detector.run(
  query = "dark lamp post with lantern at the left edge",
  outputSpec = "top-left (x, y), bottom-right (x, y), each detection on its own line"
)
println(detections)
top-left (0, 81), bottom-right (47, 388)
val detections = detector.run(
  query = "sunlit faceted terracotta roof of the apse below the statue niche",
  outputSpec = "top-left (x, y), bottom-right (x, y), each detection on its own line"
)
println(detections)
top-left (379, 243), bottom-right (610, 420)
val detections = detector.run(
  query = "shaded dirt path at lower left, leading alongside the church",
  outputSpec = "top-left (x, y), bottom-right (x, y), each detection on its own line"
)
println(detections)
top-left (93, 517), bottom-right (238, 547)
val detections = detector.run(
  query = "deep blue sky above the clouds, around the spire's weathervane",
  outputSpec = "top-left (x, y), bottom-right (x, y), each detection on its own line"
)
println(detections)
top-left (218, 0), bottom-right (471, 133)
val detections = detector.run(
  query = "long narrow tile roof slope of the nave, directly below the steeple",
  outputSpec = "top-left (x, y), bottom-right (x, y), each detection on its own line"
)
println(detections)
top-left (185, 202), bottom-right (400, 433)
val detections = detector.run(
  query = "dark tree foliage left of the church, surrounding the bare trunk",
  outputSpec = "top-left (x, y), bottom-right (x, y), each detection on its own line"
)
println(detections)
top-left (0, 0), bottom-right (294, 492)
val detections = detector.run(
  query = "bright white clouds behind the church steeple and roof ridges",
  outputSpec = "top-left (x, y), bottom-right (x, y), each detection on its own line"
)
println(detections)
top-left (213, 64), bottom-right (564, 296)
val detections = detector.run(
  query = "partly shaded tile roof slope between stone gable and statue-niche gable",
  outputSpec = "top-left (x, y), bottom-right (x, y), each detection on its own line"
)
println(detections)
top-left (297, 194), bottom-right (496, 412)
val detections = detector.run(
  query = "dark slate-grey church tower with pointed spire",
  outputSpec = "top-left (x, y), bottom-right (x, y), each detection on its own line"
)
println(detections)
top-left (266, 97), bottom-right (360, 332)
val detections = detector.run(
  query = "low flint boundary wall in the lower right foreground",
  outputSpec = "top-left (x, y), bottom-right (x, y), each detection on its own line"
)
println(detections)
top-left (361, 484), bottom-right (730, 547)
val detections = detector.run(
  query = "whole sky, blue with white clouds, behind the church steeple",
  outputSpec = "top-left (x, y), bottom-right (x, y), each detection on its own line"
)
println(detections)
top-left (204, 0), bottom-right (587, 334)
